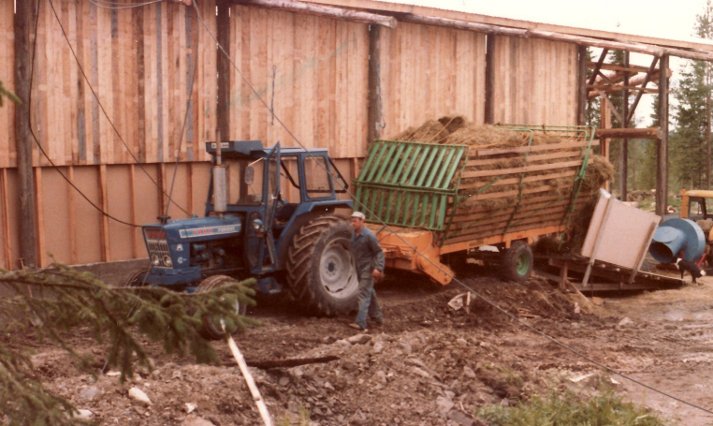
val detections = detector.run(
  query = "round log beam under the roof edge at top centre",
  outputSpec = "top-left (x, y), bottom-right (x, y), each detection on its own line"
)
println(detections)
top-left (233, 0), bottom-right (396, 28)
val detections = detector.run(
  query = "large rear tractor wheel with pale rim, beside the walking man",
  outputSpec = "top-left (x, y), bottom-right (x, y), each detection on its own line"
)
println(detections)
top-left (286, 215), bottom-right (359, 316)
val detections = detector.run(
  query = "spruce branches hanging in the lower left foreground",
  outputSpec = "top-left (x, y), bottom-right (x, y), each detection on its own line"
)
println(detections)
top-left (0, 265), bottom-right (254, 425)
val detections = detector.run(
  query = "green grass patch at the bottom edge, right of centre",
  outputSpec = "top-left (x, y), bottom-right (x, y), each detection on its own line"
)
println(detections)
top-left (476, 391), bottom-right (664, 426)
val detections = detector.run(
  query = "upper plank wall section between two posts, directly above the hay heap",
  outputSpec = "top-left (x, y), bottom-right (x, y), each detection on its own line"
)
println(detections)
top-left (381, 22), bottom-right (486, 137)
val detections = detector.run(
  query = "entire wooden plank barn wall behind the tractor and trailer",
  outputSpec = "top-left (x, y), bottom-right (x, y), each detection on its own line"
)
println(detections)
top-left (0, 0), bottom-right (576, 268)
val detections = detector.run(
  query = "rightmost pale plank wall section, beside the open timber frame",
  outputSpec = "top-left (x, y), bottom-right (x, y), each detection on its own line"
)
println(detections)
top-left (493, 36), bottom-right (577, 125)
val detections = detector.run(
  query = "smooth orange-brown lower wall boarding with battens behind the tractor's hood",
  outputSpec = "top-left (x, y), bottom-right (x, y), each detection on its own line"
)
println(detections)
top-left (34, 163), bottom-right (210, 265)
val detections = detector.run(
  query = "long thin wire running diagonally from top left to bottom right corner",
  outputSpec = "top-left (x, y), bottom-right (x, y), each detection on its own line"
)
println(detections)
top-left (192, 0), bottom-right (713, 414)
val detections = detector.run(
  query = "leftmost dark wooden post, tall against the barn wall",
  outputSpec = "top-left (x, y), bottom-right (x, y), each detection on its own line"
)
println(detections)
top-left (14, 1), bottom-right (38, 267)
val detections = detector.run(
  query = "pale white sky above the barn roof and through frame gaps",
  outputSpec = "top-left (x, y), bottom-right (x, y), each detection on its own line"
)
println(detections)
top-left (381, 0), bottom-right (713, 126)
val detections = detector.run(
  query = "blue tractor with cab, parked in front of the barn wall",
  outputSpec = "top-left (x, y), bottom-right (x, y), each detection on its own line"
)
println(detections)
top-left (127, 141), bottom-right (359, 315)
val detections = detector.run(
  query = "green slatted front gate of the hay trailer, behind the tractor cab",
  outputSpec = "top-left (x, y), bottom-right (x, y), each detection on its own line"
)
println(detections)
top-left (355, 141), bottom-right (468, 231)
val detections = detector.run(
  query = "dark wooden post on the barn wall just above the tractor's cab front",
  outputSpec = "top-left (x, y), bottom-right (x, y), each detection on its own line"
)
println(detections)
top-left (216, 0), bottom-right (231, 140)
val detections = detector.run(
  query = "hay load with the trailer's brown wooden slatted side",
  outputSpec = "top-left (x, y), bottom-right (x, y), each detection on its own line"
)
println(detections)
top-left (378, 116), bottom-right (613, 248)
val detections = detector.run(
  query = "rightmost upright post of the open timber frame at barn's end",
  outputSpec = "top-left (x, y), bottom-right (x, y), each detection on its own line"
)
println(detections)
top-left (656, 55), bottom-right (669, 216)
